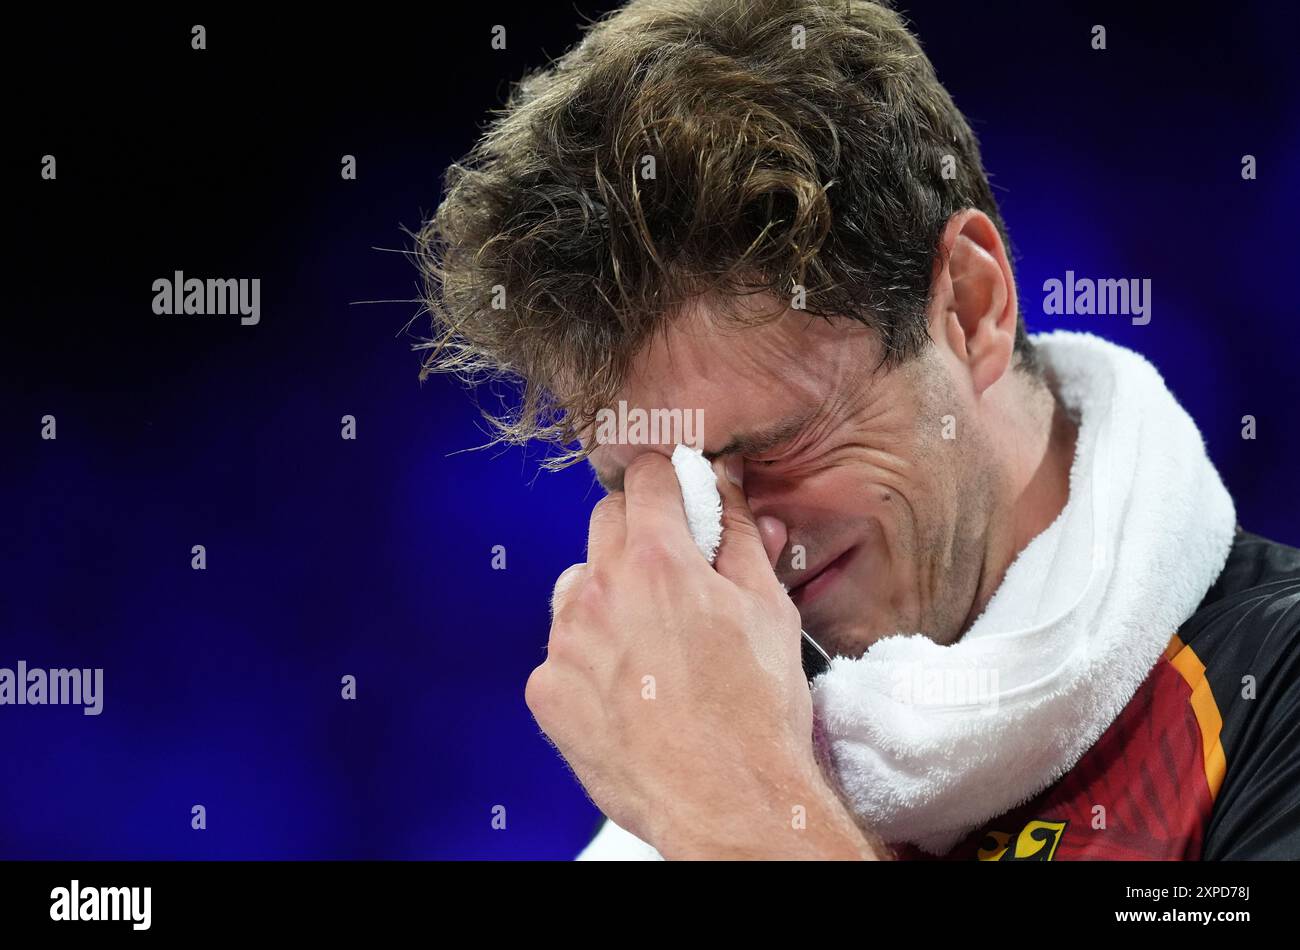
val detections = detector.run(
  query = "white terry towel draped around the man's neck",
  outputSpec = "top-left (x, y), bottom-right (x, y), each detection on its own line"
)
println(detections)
top-left (579, 331), bottom-right (1236, 859)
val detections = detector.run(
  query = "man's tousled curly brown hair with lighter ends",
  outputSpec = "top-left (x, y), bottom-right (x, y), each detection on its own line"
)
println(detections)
top-left (415, 0), bottom-right (1036, 470)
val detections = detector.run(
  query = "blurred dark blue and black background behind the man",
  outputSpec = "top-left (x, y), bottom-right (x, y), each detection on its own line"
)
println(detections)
top-left (0, 1), bottom-right (1300, 858)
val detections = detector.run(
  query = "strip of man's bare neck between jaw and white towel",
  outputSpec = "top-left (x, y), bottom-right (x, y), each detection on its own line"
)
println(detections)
top-left (962, 378), bottom-right (1078, 633)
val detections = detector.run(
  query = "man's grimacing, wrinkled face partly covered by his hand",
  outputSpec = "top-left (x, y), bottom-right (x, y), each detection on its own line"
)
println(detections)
top-left (590, 304), bottom-right (996, 656)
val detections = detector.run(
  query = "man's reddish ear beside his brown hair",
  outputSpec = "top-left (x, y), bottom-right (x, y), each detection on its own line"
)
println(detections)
top-left (931, 208), bottom-right (1018, 395)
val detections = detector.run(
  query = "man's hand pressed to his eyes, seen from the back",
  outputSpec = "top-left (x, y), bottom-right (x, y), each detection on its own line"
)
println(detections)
top-left (525, 452), bottom-right (872, 858)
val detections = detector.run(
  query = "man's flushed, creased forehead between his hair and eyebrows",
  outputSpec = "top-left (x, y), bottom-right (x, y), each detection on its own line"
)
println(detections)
top-left (590, 303), bottom-right (874, 490)
